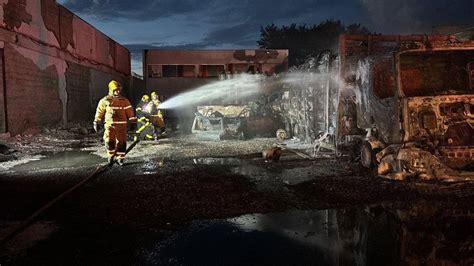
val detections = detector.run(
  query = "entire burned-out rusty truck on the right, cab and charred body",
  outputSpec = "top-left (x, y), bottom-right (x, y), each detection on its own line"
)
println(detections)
top-left (337, 35), bottom-right (474, 181)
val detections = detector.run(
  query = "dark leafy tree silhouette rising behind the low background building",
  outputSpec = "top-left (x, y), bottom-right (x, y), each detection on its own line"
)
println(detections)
top-left (257, 20), bottom-right (370, 67)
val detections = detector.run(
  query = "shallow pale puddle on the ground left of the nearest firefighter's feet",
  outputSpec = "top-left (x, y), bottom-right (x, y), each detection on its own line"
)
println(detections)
top-left (11, 151), bottom-right (101, 172)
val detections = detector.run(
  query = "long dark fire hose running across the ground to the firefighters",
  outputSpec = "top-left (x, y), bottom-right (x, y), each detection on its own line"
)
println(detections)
top-left (0, 139), bottom-right (140, 247)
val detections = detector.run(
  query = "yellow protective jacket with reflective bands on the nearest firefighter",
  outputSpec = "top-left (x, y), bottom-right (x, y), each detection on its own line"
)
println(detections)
top-left (95, 95), bottom-right (137, 126)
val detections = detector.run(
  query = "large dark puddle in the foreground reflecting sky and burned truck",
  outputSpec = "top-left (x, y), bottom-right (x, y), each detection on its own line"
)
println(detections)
top-left (139, 206), bottom-right (474, 265)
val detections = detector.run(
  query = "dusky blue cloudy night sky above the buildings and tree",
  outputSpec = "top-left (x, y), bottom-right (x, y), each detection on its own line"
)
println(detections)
top-left (58, 0), bottom-right (474, 74)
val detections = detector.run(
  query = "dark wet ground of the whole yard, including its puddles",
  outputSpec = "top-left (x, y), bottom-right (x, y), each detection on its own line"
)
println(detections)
top-left (0, 134), bottom-right (474, 265)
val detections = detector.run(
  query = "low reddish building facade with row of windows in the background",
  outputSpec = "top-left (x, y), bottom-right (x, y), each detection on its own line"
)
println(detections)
top-left (143, 49), bottom-right (288, 97)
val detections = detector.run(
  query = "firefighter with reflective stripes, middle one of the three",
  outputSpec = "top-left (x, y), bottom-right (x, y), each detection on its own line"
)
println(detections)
top-left (134, 94), bottom-right (155, 140)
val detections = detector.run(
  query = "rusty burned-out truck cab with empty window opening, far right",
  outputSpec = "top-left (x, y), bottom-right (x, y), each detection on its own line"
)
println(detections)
top-left (396, 47), bottom-right (474, 177)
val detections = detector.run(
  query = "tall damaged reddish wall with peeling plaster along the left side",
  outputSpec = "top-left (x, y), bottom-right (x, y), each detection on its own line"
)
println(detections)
top-left (0, 0), bottom-right (130, 135)
